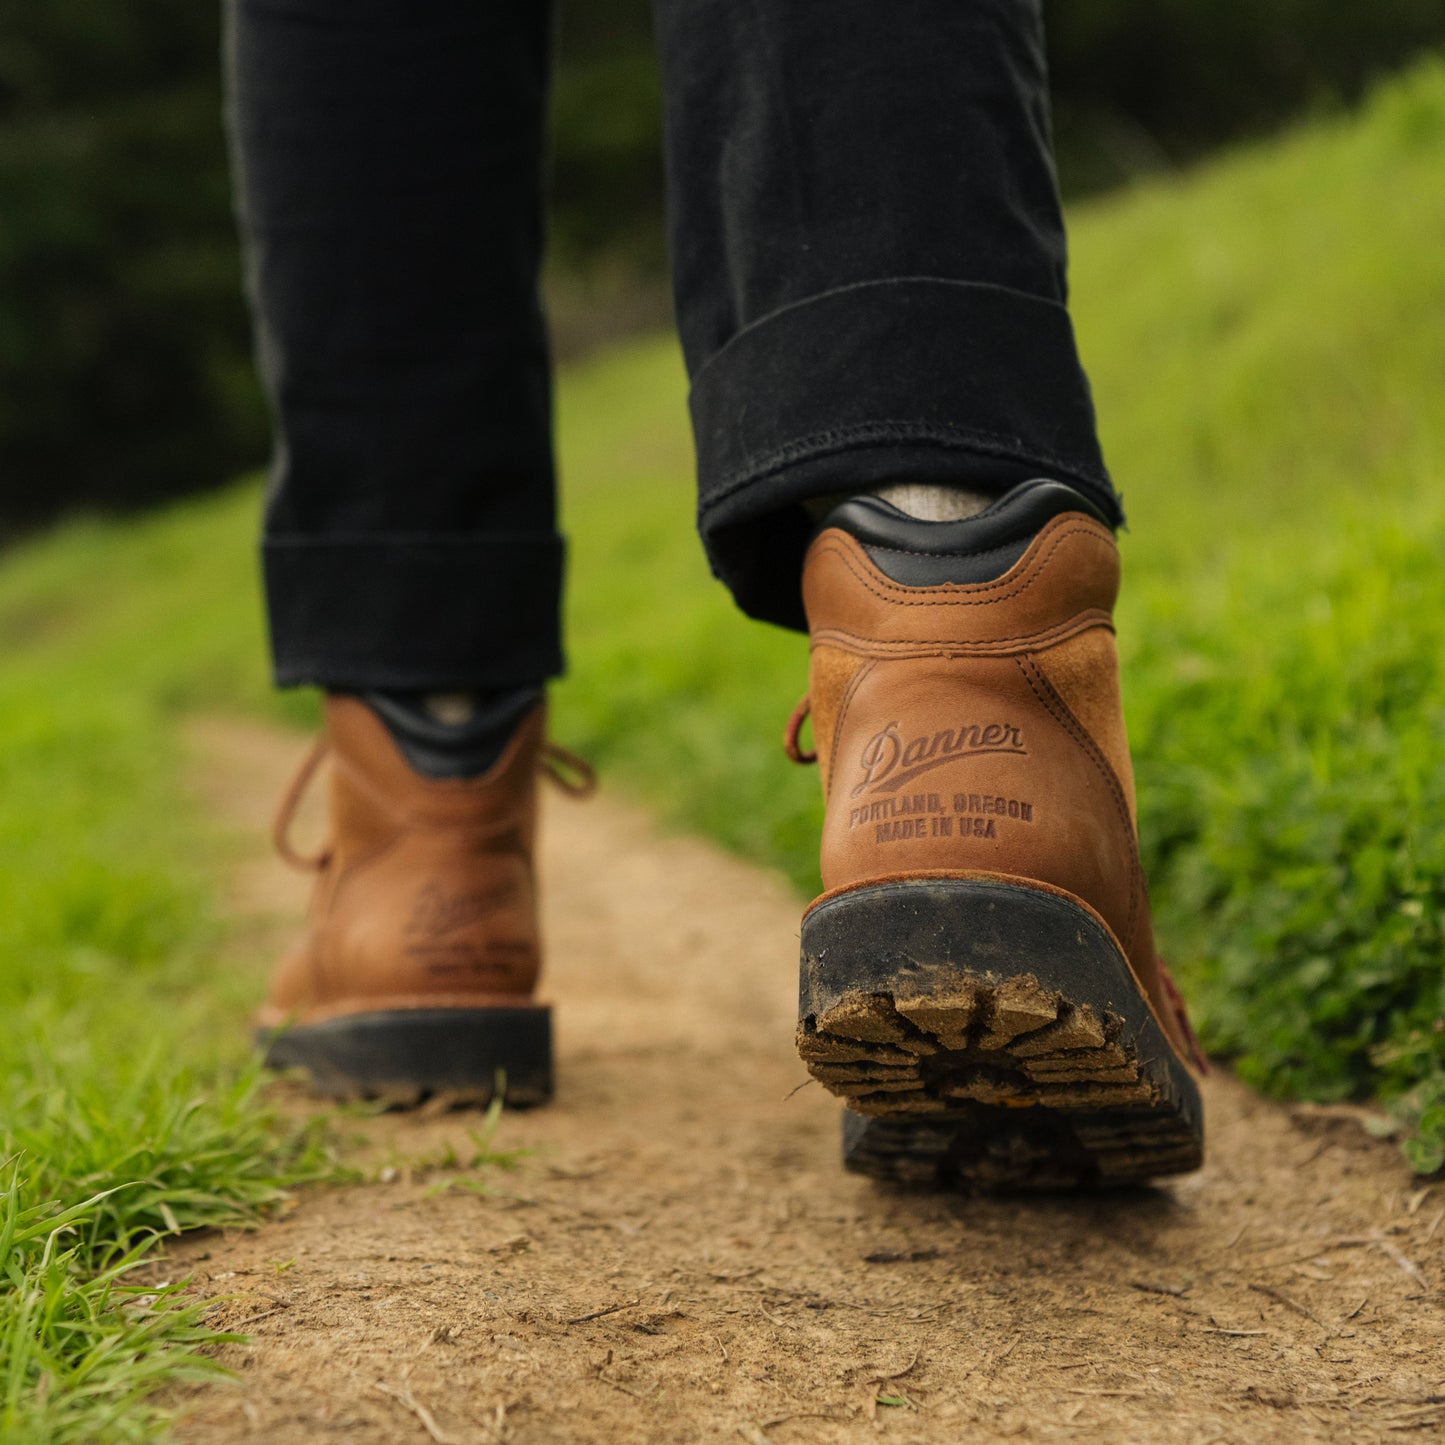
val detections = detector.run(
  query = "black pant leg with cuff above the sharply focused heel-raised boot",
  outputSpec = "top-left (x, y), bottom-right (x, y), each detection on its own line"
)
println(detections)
top-left (655, 0), bottom-right (1121, 627)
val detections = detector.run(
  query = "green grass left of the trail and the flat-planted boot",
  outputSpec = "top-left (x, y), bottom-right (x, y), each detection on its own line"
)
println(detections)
top-left (0, 491), bottom-right (328, 1442)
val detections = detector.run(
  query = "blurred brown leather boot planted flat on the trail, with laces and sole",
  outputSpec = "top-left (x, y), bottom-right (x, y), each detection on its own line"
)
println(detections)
top-left (257, 696), bottom-right (591, 1104)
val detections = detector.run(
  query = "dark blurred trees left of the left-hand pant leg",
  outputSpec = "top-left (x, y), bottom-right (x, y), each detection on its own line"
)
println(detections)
top-left (0, 0), bottom-right (266, 523)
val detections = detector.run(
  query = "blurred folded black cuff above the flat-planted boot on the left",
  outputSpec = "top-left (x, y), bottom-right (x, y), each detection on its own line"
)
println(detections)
top-left (262, 533), bottom-right (562, 691)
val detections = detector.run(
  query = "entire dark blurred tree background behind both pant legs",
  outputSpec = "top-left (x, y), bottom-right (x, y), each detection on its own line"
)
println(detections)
top-left (0, 0), bottom-right (1445, 535)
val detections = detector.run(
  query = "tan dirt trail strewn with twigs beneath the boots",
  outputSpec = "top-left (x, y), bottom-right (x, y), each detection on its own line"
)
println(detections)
top-left (168, 723), bottom-right (1445, 1445)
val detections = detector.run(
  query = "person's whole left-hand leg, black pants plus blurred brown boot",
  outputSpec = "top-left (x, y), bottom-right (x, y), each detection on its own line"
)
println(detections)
top-left (228, 0), bottom-right (575, 1103)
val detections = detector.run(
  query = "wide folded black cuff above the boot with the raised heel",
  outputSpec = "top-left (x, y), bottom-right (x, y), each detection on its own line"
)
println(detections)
top-left (691, 277), bottom-right (1123, 627)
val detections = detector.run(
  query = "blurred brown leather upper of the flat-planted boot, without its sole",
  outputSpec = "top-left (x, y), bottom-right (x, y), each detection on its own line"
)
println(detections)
top-left (260, 696), bottom-right (545, 1026)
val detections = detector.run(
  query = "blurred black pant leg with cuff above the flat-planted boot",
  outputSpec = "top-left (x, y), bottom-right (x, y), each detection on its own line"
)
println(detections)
top-left (227, 0), bottom-right (562, 689)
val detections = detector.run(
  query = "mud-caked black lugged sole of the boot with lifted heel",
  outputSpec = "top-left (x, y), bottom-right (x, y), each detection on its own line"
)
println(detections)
top-left (798, 879), bottom-right (1204, 1191)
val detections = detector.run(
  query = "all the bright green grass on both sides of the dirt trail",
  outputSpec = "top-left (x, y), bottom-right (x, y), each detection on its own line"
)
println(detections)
top-left (0, 50), bottom-right (1445, 1441)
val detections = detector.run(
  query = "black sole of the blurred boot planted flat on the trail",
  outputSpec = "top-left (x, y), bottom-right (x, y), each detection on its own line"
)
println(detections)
top-left (257, 1004), bottom-right (552, 1108)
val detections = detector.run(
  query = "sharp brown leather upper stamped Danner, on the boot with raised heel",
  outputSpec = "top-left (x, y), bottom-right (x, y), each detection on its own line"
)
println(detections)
top-left (803, 512), bottom-right (1188, 1052)
